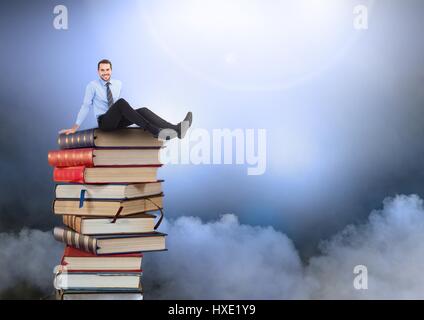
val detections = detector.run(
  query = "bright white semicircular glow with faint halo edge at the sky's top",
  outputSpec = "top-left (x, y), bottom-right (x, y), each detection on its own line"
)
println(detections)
top-left (143, 0), bottom-right (372, 90)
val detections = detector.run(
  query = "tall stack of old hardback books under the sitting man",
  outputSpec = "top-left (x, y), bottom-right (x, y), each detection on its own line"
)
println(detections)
top-left (48, 128), bottom-right (166, 300)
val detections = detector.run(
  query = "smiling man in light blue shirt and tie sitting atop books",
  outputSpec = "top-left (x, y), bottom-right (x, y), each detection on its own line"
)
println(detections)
top-left (59, 59), bottom-right (192, 139)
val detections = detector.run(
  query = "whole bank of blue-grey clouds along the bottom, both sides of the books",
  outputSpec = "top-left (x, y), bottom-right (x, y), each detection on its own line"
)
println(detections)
top-left (0, 195), bottom-right (424, 299)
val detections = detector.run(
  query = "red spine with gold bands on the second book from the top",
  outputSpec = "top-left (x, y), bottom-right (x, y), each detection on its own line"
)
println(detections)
top-left (48, 148), bottom-right (94, 167)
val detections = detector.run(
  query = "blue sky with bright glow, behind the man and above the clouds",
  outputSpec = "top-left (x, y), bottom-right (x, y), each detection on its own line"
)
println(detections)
top-left (0, 0), bottom-right (424, 255)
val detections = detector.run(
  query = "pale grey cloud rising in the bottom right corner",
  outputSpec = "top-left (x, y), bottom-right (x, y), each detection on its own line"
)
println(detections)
top-left (306, 195), bottom-right (424, 299)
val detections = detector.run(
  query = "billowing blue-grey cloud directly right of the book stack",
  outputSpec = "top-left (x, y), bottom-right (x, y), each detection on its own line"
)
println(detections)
top-left (144, 214), bottom-right (302, 299)
